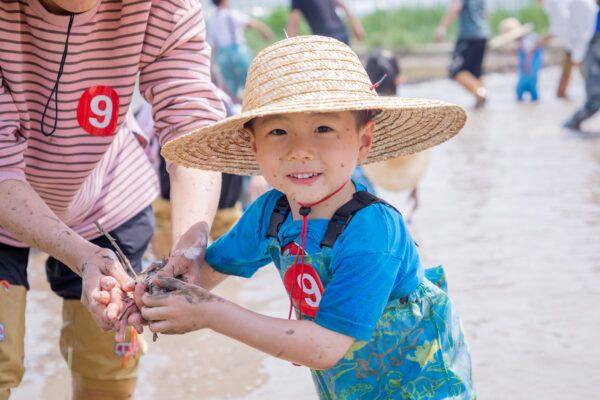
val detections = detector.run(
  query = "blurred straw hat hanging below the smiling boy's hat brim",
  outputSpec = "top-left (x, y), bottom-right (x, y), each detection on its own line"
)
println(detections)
top-left (363, 151), bottom-right (429, 192)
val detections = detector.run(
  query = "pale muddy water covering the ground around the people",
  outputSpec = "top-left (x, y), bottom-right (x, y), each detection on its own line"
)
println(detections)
top-left (13, 68), bottom-right (600, 400)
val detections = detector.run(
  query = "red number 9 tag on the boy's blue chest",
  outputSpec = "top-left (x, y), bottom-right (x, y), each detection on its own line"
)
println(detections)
top-left (283, 264), bottom-right (325, 318)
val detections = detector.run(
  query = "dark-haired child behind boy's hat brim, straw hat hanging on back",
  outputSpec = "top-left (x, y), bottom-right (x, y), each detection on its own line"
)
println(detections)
top-left (363, 49), bottom-right (429, 221)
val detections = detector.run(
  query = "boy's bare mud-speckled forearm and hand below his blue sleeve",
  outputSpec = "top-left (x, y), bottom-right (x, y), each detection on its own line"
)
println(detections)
top-left (142, 278), bottom-right (354, 369)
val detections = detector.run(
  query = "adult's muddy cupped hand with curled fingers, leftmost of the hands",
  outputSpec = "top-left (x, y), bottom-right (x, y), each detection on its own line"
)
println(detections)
top-left (79, 247), bottom-right (135, 331)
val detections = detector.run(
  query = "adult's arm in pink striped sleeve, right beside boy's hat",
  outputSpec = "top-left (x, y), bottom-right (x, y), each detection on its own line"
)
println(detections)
top-left (140, 0), bottom-right (224, 283)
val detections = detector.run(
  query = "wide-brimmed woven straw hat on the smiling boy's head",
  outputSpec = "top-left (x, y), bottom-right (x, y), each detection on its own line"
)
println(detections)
top-left (162, 36), bottom-right (466, 175)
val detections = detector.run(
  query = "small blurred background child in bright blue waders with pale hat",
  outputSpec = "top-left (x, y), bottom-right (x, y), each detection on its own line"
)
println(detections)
top-left (490, 18), bottom-right (544, 101)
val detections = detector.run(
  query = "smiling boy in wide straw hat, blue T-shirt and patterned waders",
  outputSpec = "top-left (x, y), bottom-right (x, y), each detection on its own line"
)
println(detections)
top-left (136, 36), bottom-right (475, 399)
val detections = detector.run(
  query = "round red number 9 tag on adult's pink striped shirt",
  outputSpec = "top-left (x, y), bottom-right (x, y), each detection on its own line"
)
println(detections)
top-left (77, 86), bottom-right (119, 136)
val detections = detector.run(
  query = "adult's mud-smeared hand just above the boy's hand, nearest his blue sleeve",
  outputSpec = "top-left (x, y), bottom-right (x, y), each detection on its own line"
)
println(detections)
top-left (157, 222), bottom-right (209, 285)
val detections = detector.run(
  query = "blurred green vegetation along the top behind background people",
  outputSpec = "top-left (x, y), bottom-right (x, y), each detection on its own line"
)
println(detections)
top-left (248, 4), bottom-right (548, 52)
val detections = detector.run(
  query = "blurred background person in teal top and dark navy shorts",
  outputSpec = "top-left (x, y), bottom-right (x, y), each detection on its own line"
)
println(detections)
top-left (435, 0), bottom-right (490, 108)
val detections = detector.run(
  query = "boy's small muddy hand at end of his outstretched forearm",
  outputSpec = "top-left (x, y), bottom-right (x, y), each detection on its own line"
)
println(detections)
top-left (142, 275), bottom-right (224, 334)
